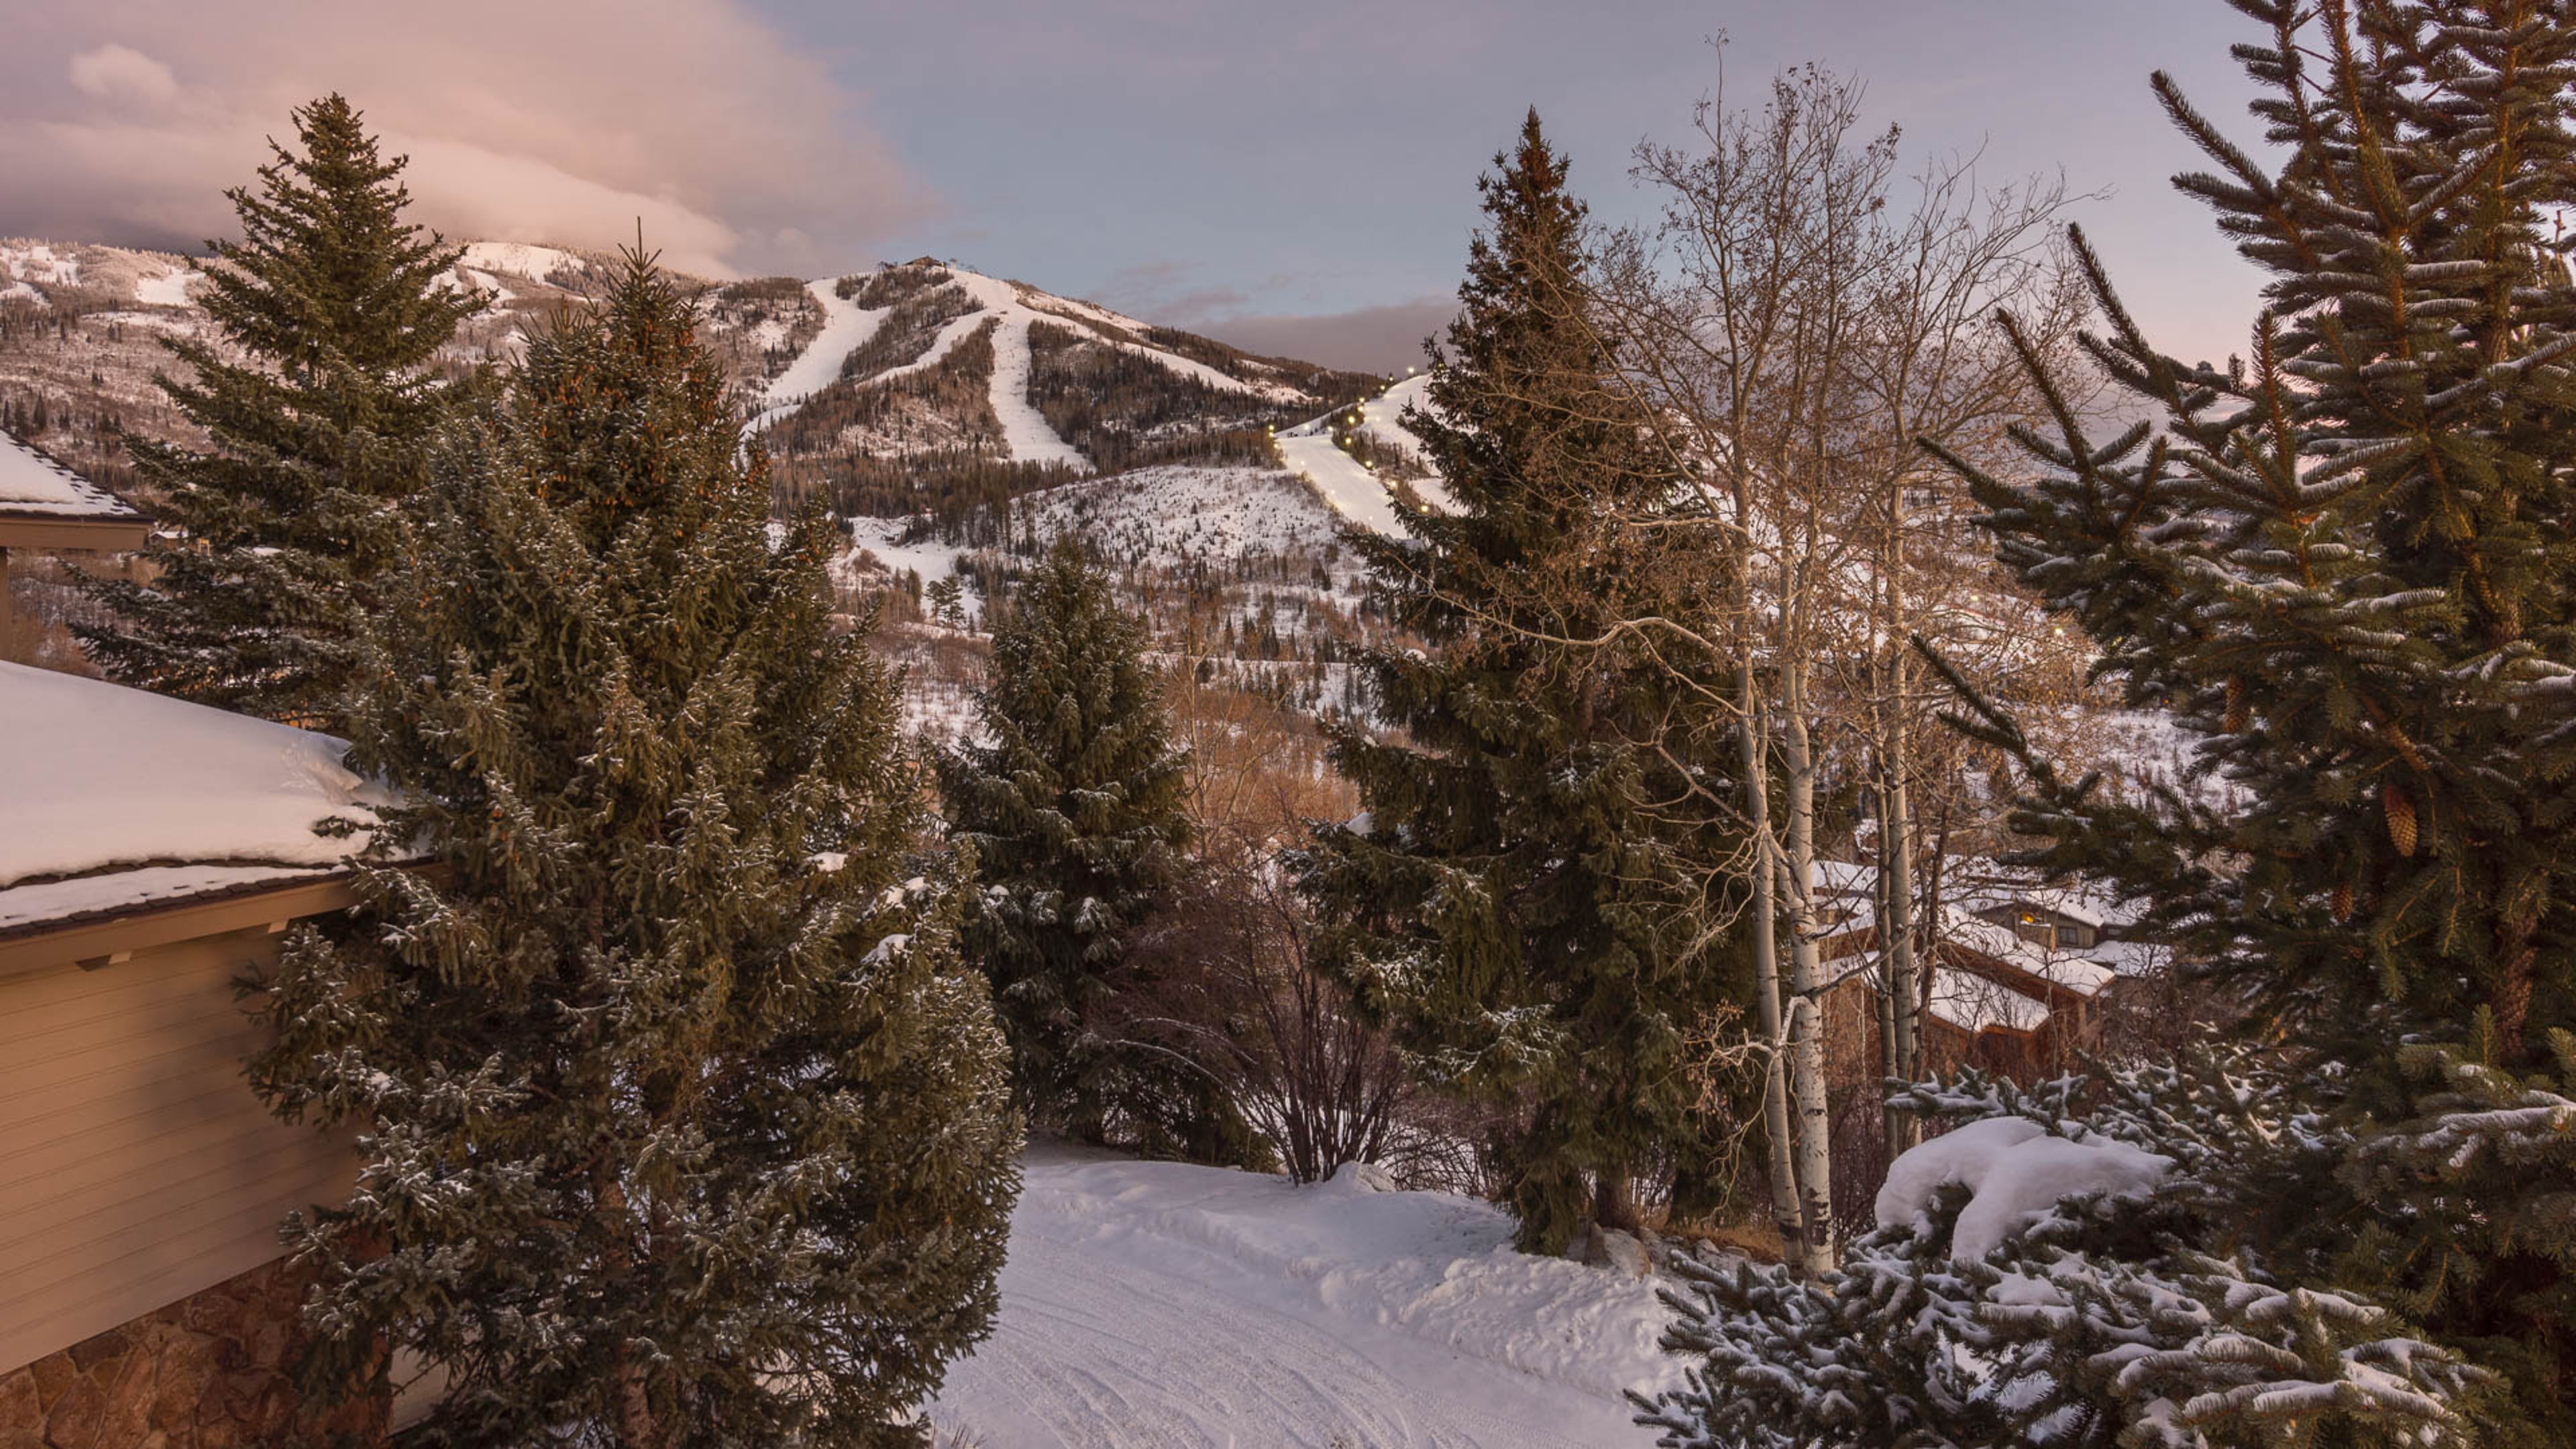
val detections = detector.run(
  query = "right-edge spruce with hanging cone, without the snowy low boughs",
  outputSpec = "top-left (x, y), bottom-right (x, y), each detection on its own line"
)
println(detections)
top-left (1906, 0), bottom-right (2576, 1441)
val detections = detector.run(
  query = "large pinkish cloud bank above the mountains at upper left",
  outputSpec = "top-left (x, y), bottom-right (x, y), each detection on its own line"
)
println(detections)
top-left (0, 0), bottom-right (935, 276)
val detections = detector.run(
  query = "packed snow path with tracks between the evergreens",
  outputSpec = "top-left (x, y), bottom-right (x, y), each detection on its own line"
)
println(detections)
top-left (930, 1147), bottom-right (1680, 1449)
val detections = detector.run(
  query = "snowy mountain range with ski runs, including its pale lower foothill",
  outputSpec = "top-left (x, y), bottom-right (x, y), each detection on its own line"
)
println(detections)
top-left (0, 239), bottom-right (1422, 691)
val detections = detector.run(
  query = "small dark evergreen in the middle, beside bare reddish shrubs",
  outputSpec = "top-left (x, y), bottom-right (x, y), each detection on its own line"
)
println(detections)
top-left (941, 539), bottom-right (1187, 1142)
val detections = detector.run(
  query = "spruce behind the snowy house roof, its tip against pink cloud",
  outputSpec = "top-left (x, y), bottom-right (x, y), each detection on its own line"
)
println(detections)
top-left (80, 95), bottom-right (484, 730)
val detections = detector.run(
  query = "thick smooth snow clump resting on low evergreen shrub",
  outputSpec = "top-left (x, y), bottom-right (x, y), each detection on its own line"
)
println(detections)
top-left (1876, 1116), bottom-right (2174, 1260)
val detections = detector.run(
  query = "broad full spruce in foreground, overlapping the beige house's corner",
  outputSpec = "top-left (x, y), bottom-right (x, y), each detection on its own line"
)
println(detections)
top-left (252, 255), bottom-right (1020, 1449)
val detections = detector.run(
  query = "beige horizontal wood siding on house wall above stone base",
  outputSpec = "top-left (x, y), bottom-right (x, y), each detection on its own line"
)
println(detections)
top-left (0, 930), bottom-right (356, 1372)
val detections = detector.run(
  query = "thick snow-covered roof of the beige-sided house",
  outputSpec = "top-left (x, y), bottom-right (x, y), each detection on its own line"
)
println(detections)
top-left (0, 663), bottom-right (386, 930)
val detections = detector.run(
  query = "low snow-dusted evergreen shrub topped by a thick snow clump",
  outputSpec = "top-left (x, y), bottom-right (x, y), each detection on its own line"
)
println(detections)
top-left (1638, 1046), bottom-right (2488, 1449)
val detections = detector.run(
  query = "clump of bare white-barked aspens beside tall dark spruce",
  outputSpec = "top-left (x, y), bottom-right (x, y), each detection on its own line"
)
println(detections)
top-left (1589, 67), bottom-right (2082, 1271)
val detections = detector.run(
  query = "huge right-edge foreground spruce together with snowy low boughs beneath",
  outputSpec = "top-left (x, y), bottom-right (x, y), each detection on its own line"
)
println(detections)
top-left (1656, 0), bottom-right (2576, 1449)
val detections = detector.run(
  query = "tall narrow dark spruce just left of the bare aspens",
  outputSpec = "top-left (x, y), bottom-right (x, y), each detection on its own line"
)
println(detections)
top-left (1303, 111), bottom-right (1744, 1250)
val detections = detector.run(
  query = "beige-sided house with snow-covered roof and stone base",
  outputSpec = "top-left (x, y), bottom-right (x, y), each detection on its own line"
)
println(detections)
top-left (0, 663), bottom-right (391, 1449)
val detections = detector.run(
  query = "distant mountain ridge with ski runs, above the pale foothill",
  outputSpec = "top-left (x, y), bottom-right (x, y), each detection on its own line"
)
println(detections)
top-left (0, 239), bottom-right (1378, 513)
